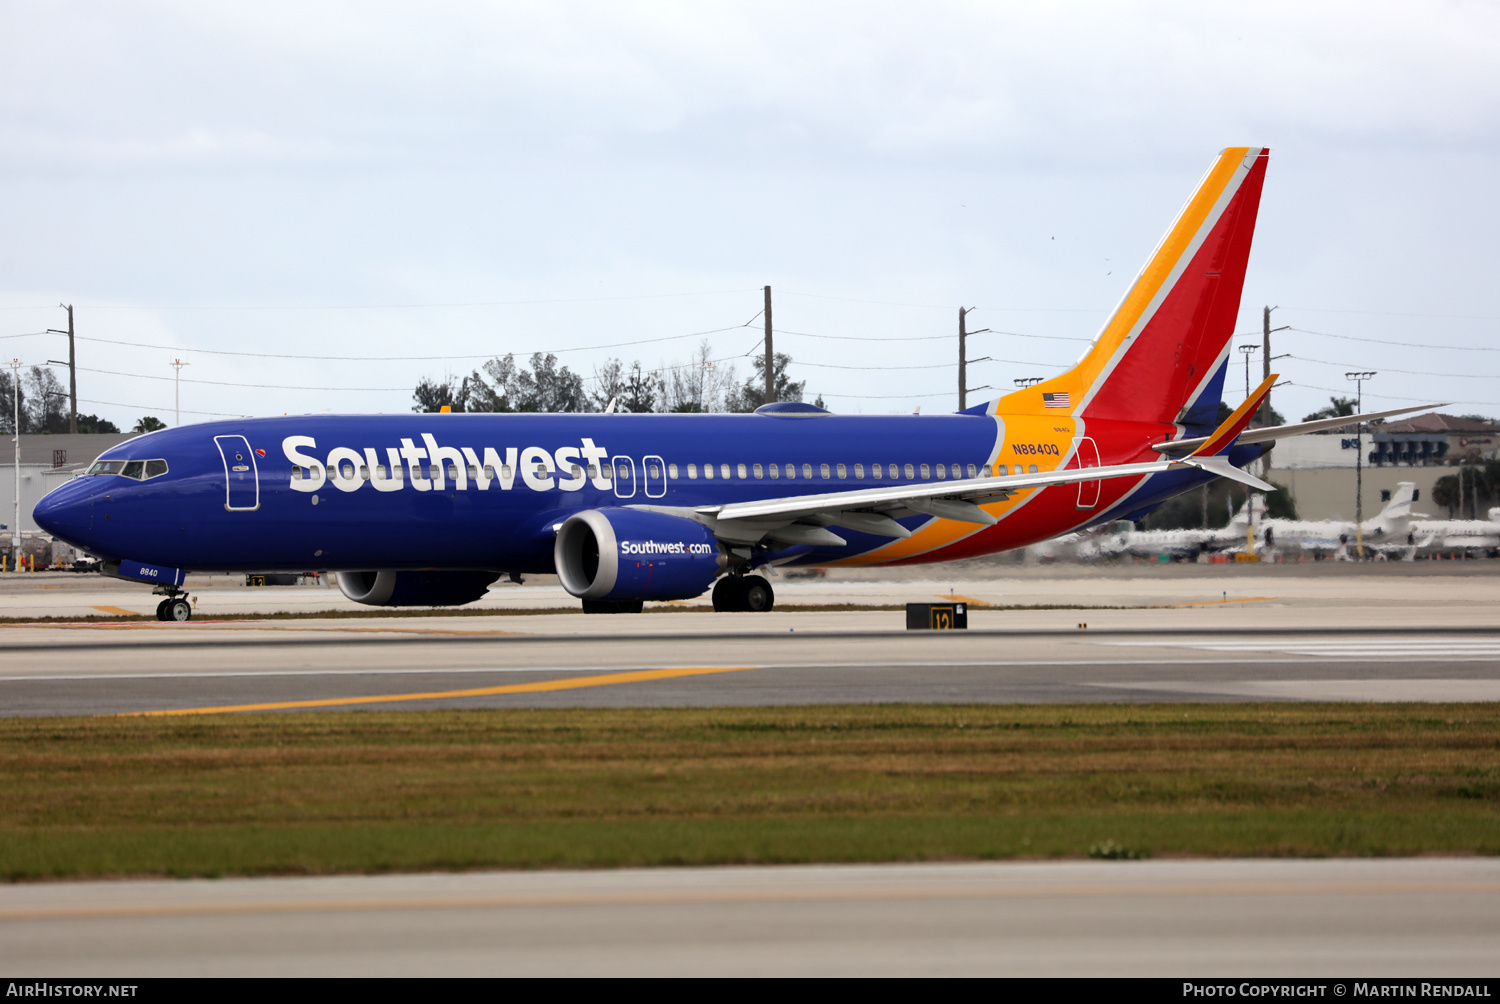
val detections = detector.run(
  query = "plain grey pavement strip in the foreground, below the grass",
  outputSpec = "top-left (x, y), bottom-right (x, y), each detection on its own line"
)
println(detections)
top-left (0, 858), bottom-right (1500, 972)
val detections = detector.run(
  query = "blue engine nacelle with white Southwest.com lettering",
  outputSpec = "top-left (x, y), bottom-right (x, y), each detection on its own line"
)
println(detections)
top-left (552, 507), bottom-right (725, 600)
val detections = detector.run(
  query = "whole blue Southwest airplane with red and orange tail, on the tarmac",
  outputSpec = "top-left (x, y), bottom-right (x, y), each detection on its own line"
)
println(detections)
top-left (36, 147), bottom-right (1416, 620)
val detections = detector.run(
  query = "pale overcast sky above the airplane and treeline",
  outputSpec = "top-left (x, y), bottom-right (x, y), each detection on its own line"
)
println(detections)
top-left (0, 0), bottom-right (1500, 428)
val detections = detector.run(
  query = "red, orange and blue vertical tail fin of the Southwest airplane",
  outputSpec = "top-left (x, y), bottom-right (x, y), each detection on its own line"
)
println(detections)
top-left (992, 147), bottom-right (1269, 428)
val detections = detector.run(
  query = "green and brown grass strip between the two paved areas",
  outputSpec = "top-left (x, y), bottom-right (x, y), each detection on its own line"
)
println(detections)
top-left (0, 704), bottom-right (1500, 879)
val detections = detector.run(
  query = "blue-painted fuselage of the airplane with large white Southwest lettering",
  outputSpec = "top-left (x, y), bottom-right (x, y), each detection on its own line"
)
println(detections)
top-left (36, 414), bottom-right (1259, 572)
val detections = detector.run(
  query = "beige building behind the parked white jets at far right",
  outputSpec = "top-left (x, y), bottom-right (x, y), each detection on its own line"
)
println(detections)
top-left (1268, 413), bottom-right (1500, 519)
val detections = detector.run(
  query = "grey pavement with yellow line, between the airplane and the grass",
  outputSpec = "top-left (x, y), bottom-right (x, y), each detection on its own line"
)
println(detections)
top-left (0, 563), bottom-right (1500, 716)
